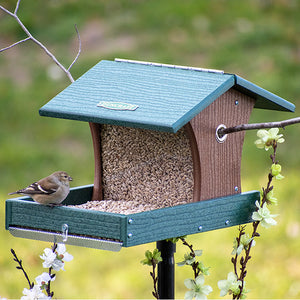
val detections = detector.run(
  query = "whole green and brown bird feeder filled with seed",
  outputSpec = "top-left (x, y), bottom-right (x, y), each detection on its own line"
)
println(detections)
top-left (6, 59), bottom-right (295, 251)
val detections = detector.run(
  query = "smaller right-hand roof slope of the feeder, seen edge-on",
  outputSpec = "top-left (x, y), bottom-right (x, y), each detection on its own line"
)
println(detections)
top-left (235, 75), bottom-right (295, 112)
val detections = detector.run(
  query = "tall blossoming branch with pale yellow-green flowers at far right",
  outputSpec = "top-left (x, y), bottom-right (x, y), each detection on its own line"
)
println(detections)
top-left (218, 128), bottom-right (284, 299)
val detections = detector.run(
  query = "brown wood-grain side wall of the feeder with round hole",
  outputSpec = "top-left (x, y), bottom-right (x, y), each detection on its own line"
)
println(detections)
top-left (190, 89), bottom-right (255, 201)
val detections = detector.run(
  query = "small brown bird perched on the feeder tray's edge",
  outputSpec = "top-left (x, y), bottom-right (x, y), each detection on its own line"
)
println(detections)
top-left (8, 171), bottom-right (73, 206)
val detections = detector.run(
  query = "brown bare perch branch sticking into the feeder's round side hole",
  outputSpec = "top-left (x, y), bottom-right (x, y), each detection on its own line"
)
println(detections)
top-left (218, 117), bottom-right (300, 136)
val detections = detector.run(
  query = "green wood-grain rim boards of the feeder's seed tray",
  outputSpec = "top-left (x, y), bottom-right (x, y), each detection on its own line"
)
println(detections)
top-left (6, 186), bottom-right (260, 247)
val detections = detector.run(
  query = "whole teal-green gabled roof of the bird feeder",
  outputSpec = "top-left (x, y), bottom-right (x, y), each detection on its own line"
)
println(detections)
top-left (40, 60), bottom-right (295, 132)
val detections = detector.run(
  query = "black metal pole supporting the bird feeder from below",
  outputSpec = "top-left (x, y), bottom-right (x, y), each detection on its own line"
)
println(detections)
top-left (156, 240), bottom-right (176, 299)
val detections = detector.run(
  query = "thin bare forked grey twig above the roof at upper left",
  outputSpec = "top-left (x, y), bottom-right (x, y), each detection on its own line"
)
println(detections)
top-left (0, 0), bottom-right (81, 82)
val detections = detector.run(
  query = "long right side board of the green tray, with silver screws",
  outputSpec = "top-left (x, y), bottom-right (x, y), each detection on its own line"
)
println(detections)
top-left (123, 191), bottom-right (260, 247)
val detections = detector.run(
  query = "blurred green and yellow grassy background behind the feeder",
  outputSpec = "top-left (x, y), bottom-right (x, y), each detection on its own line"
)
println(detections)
top-left (0, 0), bottom-right (300, 299)
